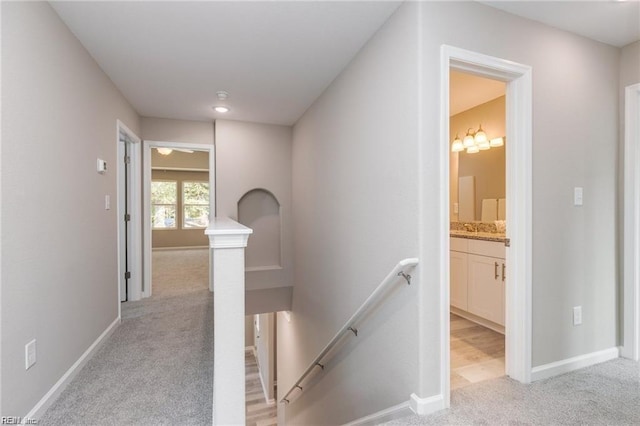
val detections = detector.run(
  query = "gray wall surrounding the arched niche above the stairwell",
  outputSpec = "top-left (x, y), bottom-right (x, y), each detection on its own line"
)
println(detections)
top-left (215, 120), bottom-right (293, 290)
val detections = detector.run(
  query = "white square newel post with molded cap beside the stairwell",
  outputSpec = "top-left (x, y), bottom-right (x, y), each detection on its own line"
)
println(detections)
top-left (205, 218), bottom-right (253, 425)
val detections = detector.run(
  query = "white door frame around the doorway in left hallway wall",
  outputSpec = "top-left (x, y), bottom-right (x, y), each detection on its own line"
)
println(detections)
top-left (116, 120), bottom-right (142, 308)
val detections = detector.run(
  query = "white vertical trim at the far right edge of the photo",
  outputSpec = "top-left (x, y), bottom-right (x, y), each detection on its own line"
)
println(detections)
top-left (622, 84), bottom-right (640, 361)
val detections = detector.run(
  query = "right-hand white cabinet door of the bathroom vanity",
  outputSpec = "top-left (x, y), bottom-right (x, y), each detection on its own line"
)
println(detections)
top-left (467, 254), bottom-right (504, 325)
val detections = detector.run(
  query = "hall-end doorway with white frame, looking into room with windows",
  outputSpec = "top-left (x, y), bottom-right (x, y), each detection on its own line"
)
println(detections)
top-left (142, 141), bottom-right (215, 297)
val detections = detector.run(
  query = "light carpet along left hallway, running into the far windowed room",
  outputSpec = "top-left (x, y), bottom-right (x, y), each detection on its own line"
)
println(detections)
top-left (38, 250), bottom-right (213, 425)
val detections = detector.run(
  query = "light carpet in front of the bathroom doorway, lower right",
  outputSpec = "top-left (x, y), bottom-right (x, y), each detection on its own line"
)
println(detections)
top-left (385, 359), bottom-right (640, 426)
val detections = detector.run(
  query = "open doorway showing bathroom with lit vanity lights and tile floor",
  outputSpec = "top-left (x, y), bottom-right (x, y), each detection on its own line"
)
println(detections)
top-left (449, 70), bottom-right (508, 390)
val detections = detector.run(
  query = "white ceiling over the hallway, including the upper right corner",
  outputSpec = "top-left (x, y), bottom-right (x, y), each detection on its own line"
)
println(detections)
top-left (52, 0), bottom-right (640, 125)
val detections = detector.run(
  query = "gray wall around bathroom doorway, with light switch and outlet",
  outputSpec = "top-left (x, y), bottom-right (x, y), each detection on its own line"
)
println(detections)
top-left (419, 2), bottom-right (619, 390)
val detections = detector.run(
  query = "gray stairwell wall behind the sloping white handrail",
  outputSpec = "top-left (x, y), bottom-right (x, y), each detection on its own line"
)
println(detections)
top-left (277, 3), bottom-right (419, 424)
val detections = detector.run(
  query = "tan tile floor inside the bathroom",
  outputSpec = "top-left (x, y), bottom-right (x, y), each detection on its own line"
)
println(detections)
top-left (450, 314), bottom-right (505, 389)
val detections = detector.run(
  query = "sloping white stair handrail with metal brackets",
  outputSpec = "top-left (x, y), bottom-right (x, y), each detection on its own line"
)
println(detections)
top-left (280, 257), bottom-right (418, 404)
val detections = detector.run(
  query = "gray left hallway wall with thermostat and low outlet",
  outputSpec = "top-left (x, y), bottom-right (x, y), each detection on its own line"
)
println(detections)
top-left (0, 2), bottom-right (139, 416)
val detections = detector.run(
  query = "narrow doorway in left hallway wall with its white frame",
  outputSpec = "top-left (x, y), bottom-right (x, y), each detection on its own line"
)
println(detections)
top-left (116, 120), bottom-right (142, 310)
